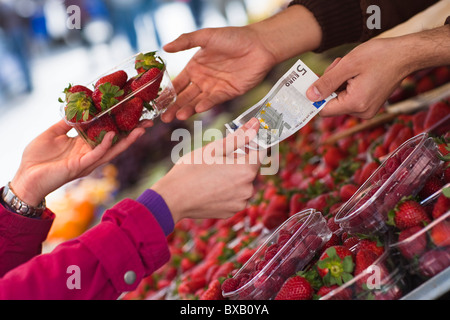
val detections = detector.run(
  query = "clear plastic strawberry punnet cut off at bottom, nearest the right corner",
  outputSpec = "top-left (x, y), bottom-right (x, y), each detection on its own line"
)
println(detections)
top-left (320, 232), bottom-right (410, 300)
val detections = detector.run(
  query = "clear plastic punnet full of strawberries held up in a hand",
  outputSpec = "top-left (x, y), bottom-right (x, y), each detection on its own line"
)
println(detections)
top-left (59, 51), bottom-right (176, 147)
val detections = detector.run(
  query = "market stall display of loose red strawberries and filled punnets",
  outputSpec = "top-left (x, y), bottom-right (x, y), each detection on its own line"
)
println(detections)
top-left (118, 67), bottom-right (450, 300)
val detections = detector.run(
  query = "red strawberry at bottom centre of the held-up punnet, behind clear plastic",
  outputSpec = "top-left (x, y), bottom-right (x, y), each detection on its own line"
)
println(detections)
top-left (111, 97), bottom-right (144, 131)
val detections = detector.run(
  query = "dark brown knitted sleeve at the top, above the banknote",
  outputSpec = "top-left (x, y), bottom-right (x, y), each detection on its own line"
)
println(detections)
top-left (289, 0), bottom-right (437, 52)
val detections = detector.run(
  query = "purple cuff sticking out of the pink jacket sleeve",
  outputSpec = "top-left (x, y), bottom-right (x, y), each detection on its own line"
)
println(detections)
top-left (136, 189), bottom-right (175, 236)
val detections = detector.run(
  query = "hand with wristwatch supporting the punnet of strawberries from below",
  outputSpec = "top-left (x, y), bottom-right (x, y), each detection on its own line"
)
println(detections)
top-left (11, 120), bottom-right (153, 206)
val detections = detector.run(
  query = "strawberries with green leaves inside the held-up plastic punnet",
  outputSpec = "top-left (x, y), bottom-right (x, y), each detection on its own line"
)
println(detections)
top-left (59, 52), bottom-right (164, 146)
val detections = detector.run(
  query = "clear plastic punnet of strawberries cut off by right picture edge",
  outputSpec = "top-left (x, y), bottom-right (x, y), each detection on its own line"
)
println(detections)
top-left (390, 189), bottom-right (450, 281)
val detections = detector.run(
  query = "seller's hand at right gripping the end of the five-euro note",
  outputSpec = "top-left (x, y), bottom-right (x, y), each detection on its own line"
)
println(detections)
top-left (307, 38), bottom-right (413, 119)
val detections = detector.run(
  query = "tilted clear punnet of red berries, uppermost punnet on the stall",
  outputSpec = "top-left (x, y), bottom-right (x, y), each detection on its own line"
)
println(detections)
top-left (335, 133), bottom-right (441, 235)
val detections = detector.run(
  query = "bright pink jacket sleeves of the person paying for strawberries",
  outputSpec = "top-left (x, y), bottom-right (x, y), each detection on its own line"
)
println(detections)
top-left (0, 199), bottom-right (170, 299)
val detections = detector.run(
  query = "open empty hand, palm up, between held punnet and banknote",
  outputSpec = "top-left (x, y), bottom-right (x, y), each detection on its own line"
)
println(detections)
top-left (161, 27), bottom-right (276, 122)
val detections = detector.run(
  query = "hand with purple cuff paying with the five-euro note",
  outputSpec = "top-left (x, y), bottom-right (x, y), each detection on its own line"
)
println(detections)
top-left (152, 118), bottom-right (260, 222)
